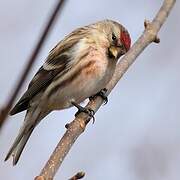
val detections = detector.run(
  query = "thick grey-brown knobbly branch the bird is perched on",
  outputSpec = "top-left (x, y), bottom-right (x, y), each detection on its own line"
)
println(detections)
top-left (35, 0), bottom-right (175, 180)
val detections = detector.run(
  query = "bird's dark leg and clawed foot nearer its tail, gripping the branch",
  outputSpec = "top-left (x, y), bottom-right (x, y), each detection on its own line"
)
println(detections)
top-left (71, 102), bottom-right (95, 123)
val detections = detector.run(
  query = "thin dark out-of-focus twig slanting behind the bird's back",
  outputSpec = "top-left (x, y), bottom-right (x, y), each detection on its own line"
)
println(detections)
top-left (0, 0), bottom-right (67, 128)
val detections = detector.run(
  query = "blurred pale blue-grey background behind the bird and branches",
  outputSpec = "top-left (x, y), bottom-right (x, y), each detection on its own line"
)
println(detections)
top-left (0, 0), bottom-right (180, 180)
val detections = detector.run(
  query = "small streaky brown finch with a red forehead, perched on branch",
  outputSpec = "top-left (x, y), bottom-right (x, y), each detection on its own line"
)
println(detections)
top-left (5, 20), bottom-right (131, 165)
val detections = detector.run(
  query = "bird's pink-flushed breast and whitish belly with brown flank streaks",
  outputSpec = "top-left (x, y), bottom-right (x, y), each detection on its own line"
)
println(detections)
top-left (46, 46), bottom-right (116, 109)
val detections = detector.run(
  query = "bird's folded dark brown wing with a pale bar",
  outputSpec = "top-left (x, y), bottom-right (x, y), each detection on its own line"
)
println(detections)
top-left (10, 28), bottom-right (88, 115)
